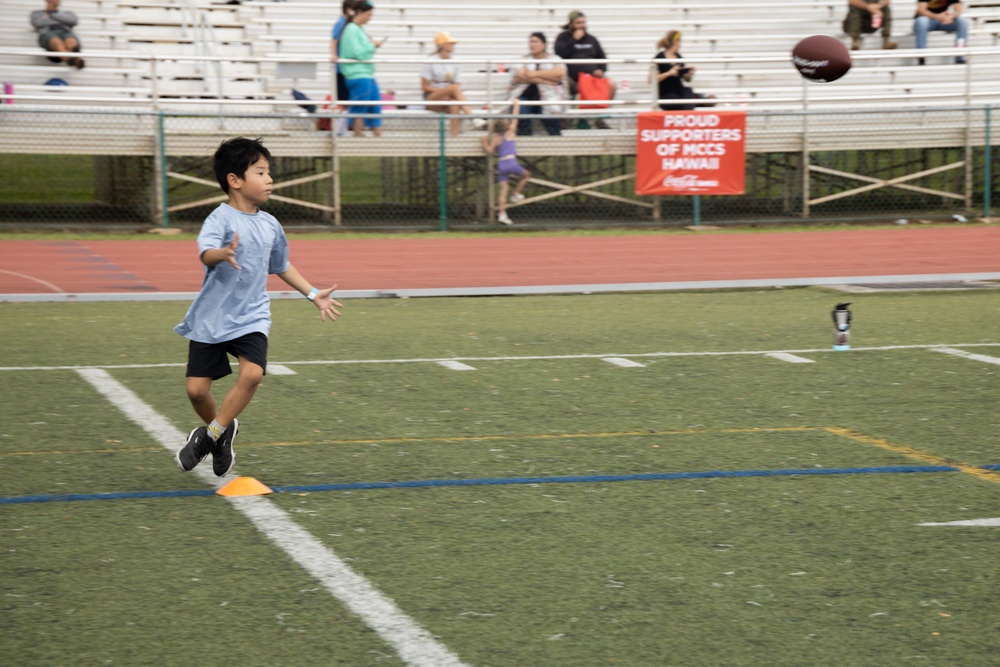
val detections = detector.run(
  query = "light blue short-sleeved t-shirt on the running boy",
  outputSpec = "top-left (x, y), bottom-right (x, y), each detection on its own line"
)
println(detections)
top-left (174, 204), bottom-right (289, 343)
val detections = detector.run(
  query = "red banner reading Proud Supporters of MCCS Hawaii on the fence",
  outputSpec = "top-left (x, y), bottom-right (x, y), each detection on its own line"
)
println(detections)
top-left (635, 110), bottom-right (746, 195)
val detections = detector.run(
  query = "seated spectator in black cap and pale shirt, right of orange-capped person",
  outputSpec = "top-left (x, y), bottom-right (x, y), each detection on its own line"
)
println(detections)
top-left (507, 32), bottom-right (569, 136)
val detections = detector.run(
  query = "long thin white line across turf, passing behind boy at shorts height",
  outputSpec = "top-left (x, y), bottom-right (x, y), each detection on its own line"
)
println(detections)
top-left (0, 343), bottom-right (1000, 371)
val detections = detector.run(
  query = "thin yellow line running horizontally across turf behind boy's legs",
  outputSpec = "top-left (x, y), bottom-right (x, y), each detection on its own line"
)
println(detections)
top-left (0, 426), bottom-right (824, 458)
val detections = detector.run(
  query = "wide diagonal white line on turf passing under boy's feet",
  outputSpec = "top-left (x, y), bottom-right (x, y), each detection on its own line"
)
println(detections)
top-left (77, 368), bottom-right (465, 667)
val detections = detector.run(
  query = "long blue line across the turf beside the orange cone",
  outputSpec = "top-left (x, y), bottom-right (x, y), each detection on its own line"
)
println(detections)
top-left (0, 465), bottom-right (956, 505)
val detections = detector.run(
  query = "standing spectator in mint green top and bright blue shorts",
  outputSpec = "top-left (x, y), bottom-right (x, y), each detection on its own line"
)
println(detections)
top-left (340, 2), bottom-right (382, 137)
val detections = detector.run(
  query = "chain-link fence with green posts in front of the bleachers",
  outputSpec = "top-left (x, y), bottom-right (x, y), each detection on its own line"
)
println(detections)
top-left (0, 106), bottom-right (1000, 230)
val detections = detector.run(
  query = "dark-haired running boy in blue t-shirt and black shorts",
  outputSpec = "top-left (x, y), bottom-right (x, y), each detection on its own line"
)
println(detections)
top-left (174, 137), bottom-right (341, 477)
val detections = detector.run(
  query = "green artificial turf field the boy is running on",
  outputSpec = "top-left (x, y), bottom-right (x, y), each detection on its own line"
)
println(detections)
top-left (0, 289), bottom-right (1000, 667)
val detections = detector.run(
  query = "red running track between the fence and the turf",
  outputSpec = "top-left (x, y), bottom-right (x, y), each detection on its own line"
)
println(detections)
top-left (0, 225), bottom-right (1000, 295)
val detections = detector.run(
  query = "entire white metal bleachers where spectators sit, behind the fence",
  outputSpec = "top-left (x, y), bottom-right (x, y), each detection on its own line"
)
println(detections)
top-left (0, 0), bottom-right (1000, 116)
